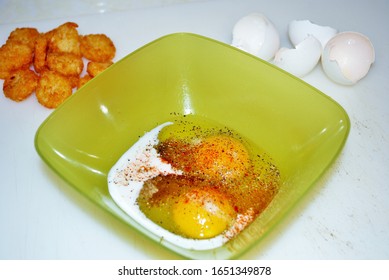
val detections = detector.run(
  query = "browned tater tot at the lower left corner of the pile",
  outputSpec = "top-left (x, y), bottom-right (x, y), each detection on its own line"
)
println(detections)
top-left (3, 69), bottom-right (38, 102)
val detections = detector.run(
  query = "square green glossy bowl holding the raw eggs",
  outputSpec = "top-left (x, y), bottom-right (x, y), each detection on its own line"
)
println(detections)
top-left (35, 33), bottom-right (350, 259)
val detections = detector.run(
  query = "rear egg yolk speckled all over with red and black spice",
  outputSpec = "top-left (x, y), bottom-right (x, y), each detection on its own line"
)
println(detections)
top-left (193, 135), bottom-right (250, 180)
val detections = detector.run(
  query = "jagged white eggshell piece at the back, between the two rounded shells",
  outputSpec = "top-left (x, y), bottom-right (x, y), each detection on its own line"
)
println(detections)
top-left (288, 20), bottom-right (338, 49)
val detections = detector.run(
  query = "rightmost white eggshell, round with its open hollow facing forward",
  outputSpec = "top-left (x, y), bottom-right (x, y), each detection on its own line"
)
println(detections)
top-left (322, 32), bottom-right (375, 85)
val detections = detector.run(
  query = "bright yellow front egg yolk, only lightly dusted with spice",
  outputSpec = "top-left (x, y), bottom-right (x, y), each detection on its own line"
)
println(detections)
top-left (173, 189), bottom-right (235, 239)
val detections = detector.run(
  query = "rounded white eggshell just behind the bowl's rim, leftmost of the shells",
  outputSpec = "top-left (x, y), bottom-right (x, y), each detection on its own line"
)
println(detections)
top-left (231, 13), bottom-right (280, 61)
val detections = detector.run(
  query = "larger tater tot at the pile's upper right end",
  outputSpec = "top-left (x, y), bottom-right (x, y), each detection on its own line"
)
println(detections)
top-left (80, 34), bottom-right (116, 62)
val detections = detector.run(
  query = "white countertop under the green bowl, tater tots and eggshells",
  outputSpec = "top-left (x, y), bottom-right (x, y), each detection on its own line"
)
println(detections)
top-left (0, 0), bottom-right (389, 259)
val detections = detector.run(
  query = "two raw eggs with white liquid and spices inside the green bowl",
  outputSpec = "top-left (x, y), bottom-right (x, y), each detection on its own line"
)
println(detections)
top-left (108, 115), bottom-right (280, 250)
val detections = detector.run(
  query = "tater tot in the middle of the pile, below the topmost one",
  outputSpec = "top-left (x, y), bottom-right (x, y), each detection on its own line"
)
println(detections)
top-left (46, 52), bottom-right (84, 76)
